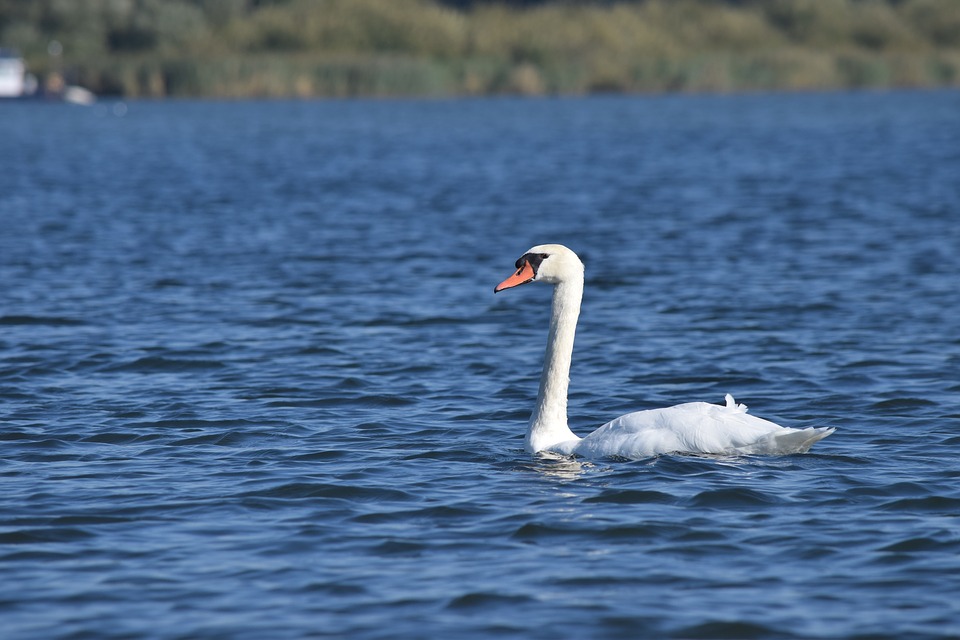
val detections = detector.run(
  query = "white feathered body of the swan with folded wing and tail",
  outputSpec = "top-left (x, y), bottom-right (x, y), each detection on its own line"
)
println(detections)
top-left (574, 396), bottom-right (834, 458)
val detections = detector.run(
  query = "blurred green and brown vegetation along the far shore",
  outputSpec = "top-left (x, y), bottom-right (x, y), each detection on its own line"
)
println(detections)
top-left (0, 0), bottom-right (960, 97)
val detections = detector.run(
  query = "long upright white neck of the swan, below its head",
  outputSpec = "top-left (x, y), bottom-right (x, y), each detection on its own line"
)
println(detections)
top-left (526, 276), bottom-right (583, 452)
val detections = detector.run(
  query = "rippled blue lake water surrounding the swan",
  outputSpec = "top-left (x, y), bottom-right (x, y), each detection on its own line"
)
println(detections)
top-left (0, 92), bottom-right (960, 639)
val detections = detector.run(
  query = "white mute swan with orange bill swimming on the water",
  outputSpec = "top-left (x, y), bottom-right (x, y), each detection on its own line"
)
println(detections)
top-left (493, 244), bottom-right (834, 459)
